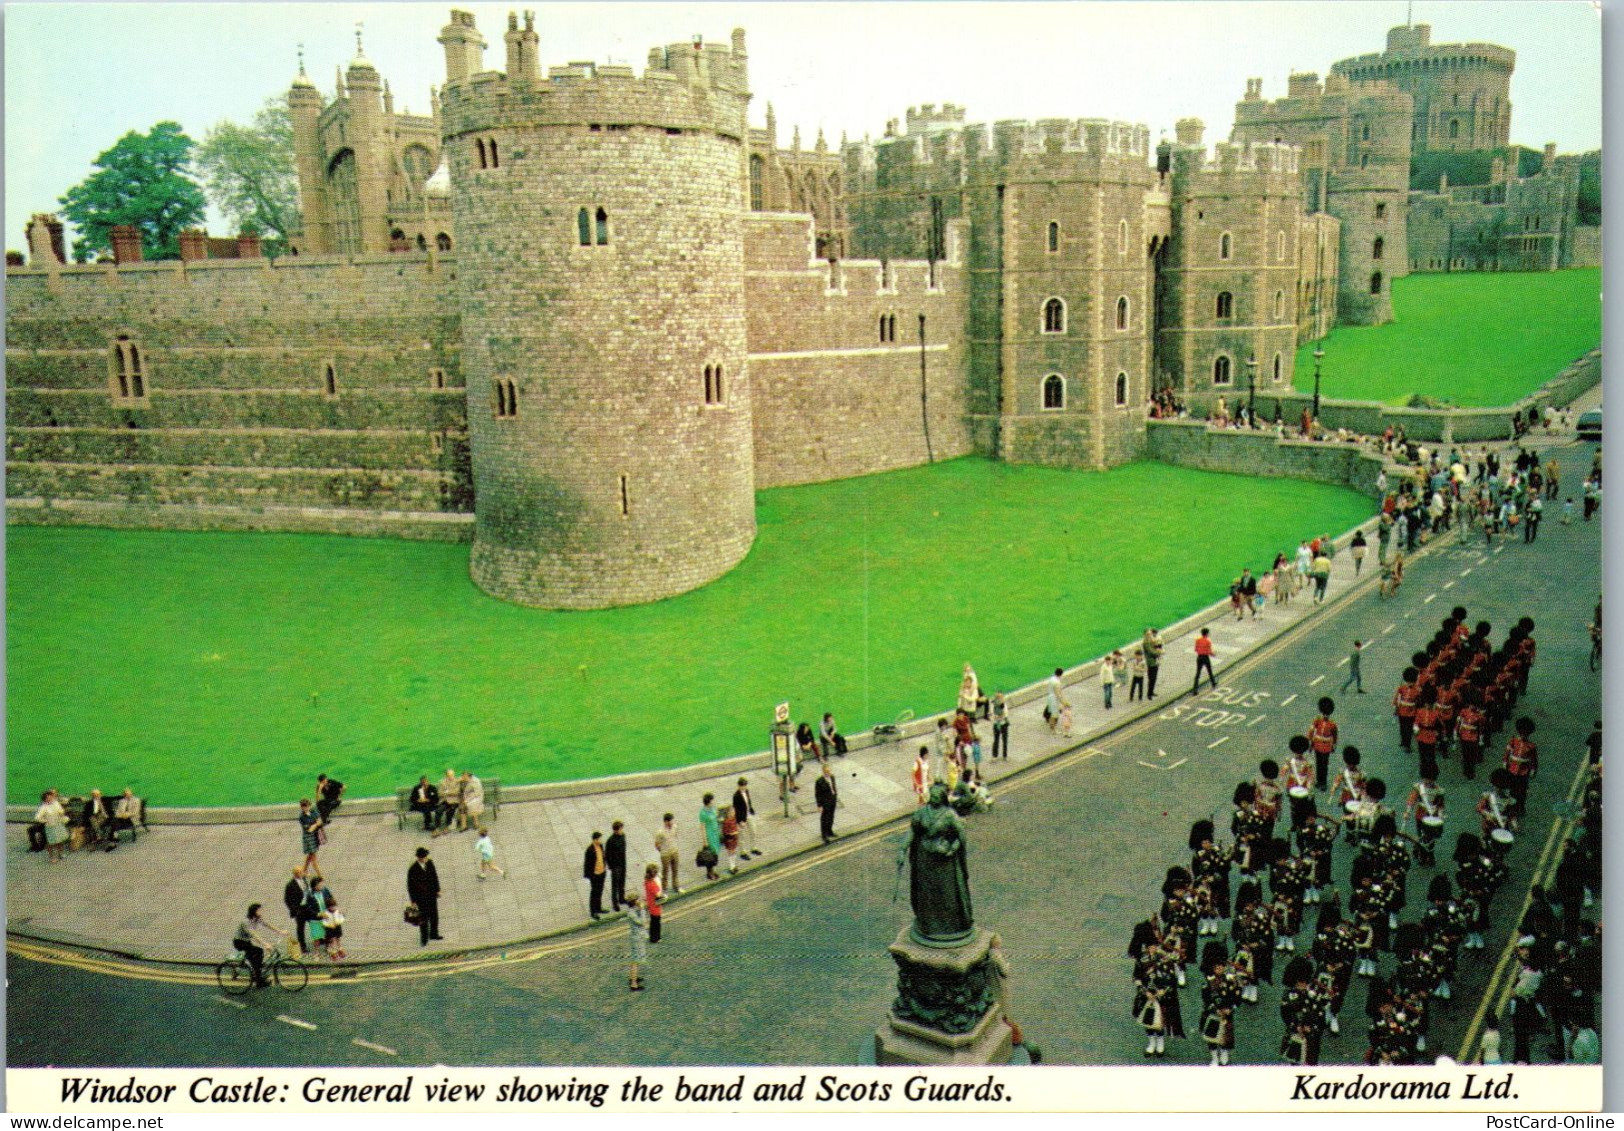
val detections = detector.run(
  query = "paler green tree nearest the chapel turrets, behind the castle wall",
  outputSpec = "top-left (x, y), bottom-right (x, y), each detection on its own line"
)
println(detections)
top-left (198, 98), bottom-right (300, 254)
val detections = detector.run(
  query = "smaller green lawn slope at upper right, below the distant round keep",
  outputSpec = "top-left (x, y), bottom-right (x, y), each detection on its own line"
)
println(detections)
top-left (1296, 268), bottom-right (1601, 406)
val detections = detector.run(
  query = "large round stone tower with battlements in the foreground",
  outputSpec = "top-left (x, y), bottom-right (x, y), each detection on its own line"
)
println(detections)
top-left (440, 11), bottom-right (755, 609)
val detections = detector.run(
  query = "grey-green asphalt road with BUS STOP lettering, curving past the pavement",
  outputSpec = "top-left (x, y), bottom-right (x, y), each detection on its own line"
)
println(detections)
top-left (8, 452), bottom-right (1601, 1064)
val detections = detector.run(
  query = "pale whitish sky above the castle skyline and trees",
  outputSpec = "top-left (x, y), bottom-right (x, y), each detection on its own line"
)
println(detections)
top-left (3, 0), bottom-right (1601, 247)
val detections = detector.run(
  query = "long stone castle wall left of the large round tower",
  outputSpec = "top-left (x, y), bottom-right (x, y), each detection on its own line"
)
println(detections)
top-left (6, 257), bottom-right (473, 512)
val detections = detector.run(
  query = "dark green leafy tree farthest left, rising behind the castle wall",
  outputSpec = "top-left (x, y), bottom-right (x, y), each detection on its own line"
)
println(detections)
top-left (60, 122), bottom-right (205, 262)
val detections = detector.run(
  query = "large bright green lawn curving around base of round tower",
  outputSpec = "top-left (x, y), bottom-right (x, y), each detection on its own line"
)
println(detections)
top-left (6, 458), bottom-right (1371, 804)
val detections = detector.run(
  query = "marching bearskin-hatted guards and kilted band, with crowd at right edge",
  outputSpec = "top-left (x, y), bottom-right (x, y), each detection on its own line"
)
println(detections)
top-left (1127, 606), bottom-right (1601, 1064)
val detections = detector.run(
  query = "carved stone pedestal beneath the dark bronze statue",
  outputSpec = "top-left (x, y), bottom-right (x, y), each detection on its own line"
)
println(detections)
top-left (874, 926), bottom-right (1010, 1064)
